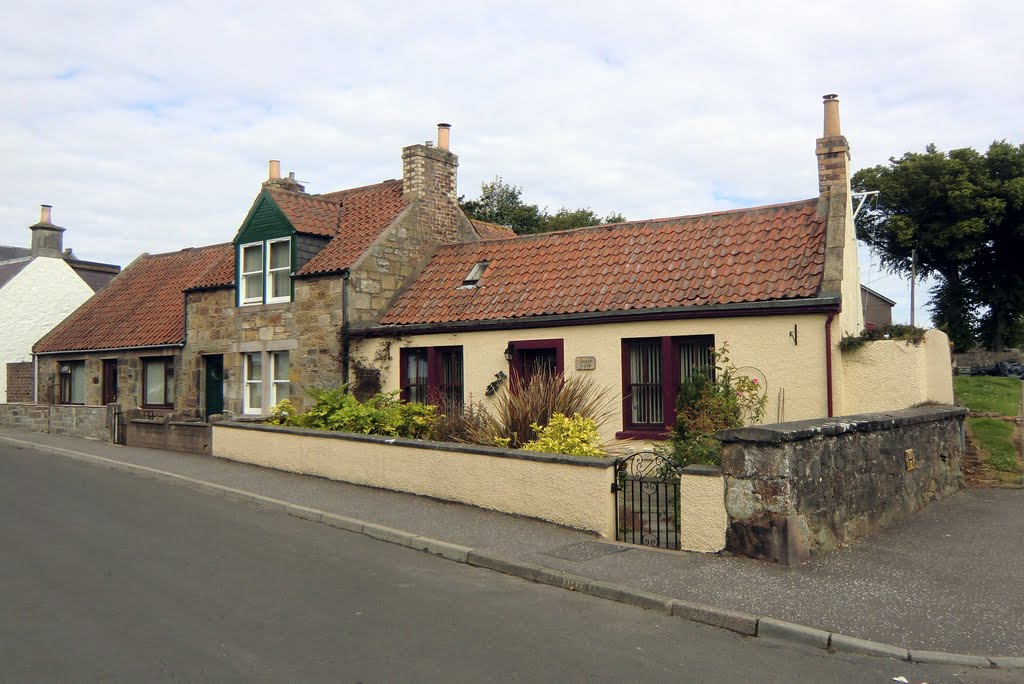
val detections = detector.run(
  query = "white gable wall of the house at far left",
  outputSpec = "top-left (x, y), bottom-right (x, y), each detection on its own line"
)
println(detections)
top-left (0, 257), bottom-right (93, 401)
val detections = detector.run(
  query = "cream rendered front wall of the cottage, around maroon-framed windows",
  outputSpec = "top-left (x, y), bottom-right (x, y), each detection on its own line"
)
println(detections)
top-left (352, 313), bottom-right (838, 441)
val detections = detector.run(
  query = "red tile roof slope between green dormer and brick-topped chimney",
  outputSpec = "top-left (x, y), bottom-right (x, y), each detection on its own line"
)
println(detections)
top-left (298, 180), bottom-right (406, 275)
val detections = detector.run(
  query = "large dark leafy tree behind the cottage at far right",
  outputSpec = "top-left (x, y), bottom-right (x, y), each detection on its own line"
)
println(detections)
top-left (853, 141), bottom-right (1024, 351)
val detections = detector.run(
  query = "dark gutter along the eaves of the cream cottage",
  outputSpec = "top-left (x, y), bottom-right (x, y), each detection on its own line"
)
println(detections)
top-left (355, 297), bottom-right (840, 337)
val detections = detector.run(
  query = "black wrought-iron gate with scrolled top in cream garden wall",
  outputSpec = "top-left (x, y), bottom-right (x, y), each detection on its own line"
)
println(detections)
top-left (611, 452), bottom-right (679, 550)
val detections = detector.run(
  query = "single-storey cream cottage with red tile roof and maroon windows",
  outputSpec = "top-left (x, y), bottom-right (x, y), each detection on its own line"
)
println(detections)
top-left (352, 95), bottom-right (952, 439)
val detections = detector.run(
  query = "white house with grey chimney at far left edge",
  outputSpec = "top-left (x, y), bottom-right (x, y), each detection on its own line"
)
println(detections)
top-left (0, 205), bottom-right (121, 402)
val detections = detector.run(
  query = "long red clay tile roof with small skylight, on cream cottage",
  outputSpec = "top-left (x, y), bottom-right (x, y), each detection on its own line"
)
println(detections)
top-left (381, 199), bottom-right (824, 325)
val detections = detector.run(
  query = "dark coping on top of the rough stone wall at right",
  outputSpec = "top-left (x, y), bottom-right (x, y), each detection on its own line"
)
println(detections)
top-left (715, 405), bottom-right (968, 444)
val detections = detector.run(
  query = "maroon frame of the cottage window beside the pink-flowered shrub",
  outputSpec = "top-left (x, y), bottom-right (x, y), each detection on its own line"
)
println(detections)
top-left (615, 335), bottom-right (715, 439)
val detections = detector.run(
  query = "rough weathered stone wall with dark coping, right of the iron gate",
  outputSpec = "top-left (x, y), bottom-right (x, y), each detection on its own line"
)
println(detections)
top-left (718, 407), bottom-right (967, 564)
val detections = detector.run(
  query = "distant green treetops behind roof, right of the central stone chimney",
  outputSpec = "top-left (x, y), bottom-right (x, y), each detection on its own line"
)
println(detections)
top-left (459, 176), bottom-right (626, 234)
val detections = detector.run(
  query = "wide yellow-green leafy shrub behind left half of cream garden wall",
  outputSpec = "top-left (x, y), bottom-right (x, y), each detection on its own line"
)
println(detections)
top-left (267, 386), bottom-right (437, 439)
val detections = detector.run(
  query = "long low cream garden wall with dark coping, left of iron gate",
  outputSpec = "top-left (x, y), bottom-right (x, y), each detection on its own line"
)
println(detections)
top-left (213, 422), bottom-right (615, 539)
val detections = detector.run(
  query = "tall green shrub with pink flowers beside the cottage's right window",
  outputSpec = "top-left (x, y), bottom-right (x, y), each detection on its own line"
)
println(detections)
top-left (667, 345), bottom-right (768, 467)
